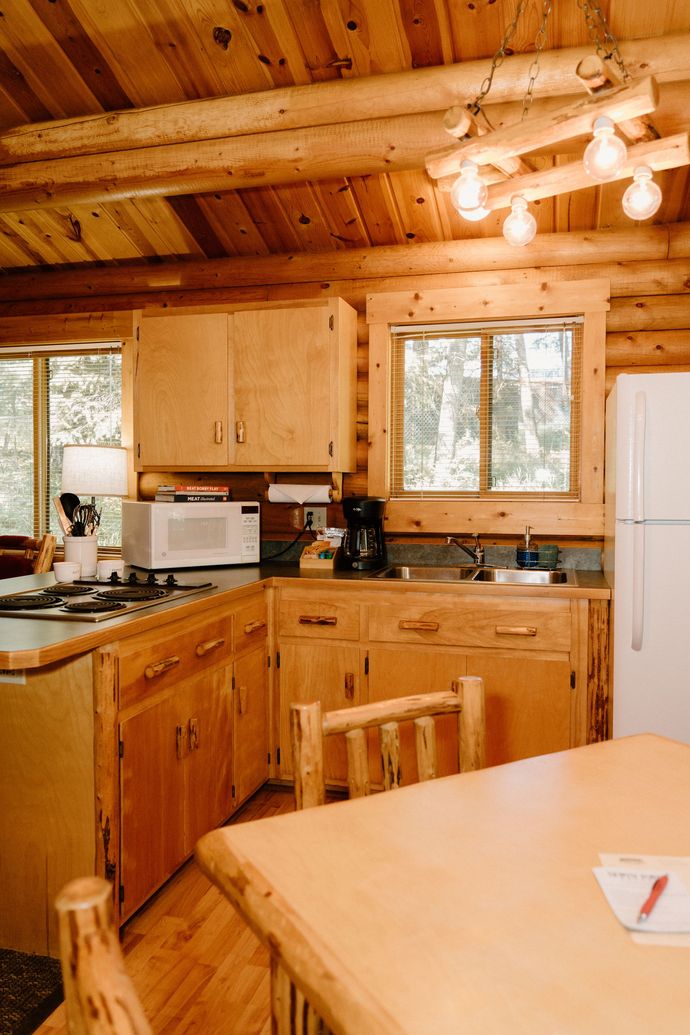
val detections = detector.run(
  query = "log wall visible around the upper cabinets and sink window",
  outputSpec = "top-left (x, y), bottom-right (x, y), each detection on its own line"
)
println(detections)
top-left (0, 224), bottom-right (690, 545)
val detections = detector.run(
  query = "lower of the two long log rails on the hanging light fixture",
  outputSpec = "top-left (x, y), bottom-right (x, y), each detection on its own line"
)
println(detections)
top-left (484, 132), bottom-right (690, 211)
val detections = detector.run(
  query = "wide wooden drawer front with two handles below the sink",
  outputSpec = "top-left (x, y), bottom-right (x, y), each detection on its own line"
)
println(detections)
top-left (368, 597), bottom-right (571, 651)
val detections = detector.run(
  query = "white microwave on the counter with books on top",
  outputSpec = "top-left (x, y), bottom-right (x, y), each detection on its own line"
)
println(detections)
top-left (122, 500), bottom-right (261, 568)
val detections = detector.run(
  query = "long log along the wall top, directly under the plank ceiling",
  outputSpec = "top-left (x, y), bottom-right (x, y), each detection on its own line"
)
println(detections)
top-left (0, 223), bottom-right (690, 315)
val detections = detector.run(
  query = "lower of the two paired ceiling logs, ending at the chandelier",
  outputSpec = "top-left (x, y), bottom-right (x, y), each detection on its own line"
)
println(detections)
top-left (0, 112), bottom-right (453, 212)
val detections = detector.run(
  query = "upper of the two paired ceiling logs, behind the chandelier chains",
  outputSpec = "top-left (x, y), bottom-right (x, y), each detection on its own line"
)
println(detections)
top-left (0, 33), bottom-right (690, 165)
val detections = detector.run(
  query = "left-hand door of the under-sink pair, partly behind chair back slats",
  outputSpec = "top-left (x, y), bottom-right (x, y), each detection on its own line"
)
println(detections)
top-left (368, 647), bottom-right (467, 785)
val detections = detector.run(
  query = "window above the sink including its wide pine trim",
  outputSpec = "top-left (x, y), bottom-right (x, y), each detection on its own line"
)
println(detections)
top-left (366, 279), bottom-right (609, 536)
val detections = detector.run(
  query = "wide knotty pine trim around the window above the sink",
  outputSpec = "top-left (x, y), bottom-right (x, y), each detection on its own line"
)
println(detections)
top-left (366, 277), bottom-right (610, 536)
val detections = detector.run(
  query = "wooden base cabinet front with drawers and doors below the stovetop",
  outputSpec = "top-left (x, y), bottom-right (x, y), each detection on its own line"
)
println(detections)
top-left (116, 593), bottom-right (268, 920)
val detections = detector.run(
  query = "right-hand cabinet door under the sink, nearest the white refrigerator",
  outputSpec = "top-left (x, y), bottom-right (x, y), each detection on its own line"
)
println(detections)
top-left (468, 654), bottom-right (573, 766)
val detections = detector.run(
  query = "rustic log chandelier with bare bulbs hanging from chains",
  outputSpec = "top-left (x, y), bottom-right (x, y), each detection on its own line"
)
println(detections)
top-left (426, 0), bottom-right (690, 245)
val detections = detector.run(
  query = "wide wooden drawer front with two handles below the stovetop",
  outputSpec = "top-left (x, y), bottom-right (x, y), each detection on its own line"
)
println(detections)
top-left (119, 615), bottom-right (233, 708)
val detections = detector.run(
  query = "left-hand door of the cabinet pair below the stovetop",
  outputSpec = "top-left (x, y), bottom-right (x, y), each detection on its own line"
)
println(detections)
top-left (120, 696), bottom-right (187, 918)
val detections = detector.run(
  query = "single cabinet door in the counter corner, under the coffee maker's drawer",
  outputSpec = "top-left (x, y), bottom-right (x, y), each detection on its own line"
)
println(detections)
top-left (280, 642), bottom-right (362, 782)
